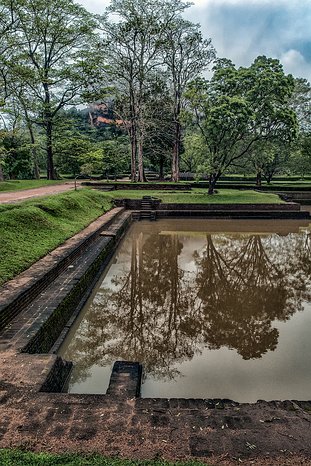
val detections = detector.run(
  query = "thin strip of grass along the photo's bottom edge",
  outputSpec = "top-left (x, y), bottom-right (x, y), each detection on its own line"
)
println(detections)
top-left (0, 450), bottom-right (206, 466)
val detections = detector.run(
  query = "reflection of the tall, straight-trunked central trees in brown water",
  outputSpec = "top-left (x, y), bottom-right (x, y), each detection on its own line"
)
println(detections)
top-left (66, 234), bottom-right (199, 380)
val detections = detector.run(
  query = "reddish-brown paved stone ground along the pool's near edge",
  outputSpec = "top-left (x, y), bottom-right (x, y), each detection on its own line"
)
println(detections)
top-left (0, 351), bottom-right (311, 465)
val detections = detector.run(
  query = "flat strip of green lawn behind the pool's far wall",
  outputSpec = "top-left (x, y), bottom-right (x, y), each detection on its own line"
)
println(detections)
top-left (109, 188), bottom-right (284, 204)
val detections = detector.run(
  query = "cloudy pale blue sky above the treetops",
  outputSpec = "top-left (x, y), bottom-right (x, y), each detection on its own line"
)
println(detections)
top-left (78, 0), bottom-right (311, 82)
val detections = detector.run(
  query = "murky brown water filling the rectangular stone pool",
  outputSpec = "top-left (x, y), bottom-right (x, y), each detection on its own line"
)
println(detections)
top-left (61, 219), bottom-right (311, 402)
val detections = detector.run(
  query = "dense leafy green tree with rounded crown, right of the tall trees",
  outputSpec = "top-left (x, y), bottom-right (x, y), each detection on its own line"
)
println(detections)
top-left (187, 56), bottom-right (297, 194)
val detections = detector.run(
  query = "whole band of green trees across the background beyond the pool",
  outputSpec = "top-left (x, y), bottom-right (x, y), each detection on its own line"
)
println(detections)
top-left (0, 0), bottom-right (311, 194)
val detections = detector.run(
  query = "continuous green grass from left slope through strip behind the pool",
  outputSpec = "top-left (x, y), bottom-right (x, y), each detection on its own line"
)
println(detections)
top-left (0, 189), bottom-right (282, 285)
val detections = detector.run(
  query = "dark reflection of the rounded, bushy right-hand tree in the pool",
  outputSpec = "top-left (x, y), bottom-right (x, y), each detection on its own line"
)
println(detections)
top-left (196, 235), bottom-right (285, 359)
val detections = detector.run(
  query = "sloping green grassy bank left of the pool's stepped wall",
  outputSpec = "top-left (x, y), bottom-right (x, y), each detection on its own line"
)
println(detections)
top-left (0, 190), bottom-right (111, 284)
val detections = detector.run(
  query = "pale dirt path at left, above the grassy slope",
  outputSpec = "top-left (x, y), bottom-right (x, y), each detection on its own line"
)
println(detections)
top-left (0, 181), bottom-right (81, 204)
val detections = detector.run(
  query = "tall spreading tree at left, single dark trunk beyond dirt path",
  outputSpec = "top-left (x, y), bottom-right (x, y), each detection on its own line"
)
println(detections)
top-left (8, 0), bottom-right (95, 179)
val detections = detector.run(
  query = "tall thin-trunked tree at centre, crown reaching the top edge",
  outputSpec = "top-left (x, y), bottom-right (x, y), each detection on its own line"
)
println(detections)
top-left (102, 0), bottom-right (190, 181)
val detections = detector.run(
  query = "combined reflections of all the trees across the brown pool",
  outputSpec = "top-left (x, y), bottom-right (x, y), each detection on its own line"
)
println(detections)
top-left (62, 229), bottom-right (311, 386)
